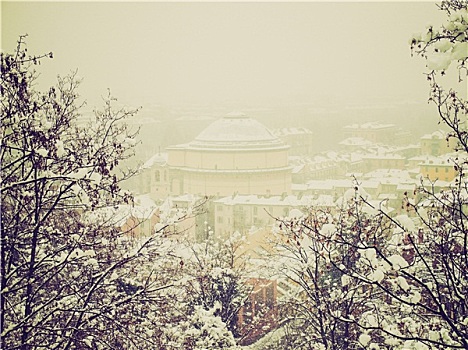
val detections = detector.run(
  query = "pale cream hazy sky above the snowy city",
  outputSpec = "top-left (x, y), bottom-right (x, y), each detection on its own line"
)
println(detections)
top-left (1, 1), bottom-right (452, 105)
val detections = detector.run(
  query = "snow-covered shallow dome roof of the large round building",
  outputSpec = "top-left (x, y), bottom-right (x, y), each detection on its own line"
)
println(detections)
top-left (190, 112), bottom-right (284, 148)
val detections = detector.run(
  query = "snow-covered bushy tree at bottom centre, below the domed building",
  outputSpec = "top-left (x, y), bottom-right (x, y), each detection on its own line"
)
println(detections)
top-left (158, 232), bottom-right (250, 349)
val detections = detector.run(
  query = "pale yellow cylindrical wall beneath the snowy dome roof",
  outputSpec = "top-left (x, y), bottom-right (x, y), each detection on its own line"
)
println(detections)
top-left (166, 145), bottom-right (292, 196)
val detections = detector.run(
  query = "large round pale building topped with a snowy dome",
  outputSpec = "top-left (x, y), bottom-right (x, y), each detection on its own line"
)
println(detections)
top-left (166, 113), bottom-right (291, 197)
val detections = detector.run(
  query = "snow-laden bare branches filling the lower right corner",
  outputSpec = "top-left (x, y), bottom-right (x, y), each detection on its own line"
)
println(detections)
top-left (273, 178), bottom-right (468, 349)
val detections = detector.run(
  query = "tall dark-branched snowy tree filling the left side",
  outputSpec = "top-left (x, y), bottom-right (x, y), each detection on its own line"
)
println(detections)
top-left (0, 37), bottom-right (181, 349)
